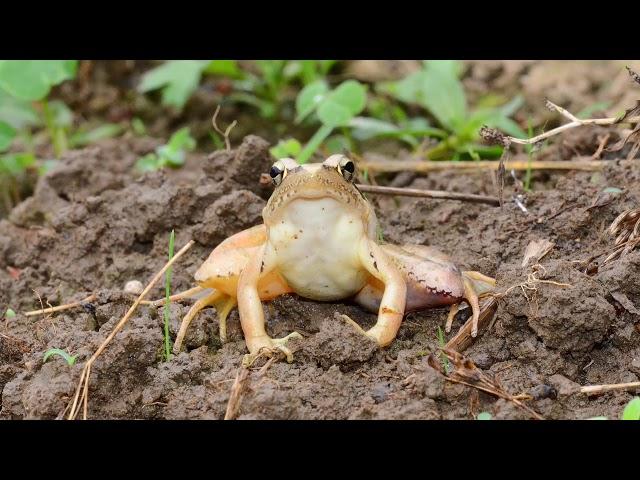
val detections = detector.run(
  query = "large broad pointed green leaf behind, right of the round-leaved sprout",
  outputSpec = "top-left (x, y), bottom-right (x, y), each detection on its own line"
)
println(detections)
top-left (378, 62), bottom-right (467, 132)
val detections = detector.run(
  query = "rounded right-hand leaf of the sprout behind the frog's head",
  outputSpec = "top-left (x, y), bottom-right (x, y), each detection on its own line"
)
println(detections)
top-left (318, 80), bottom-right (367, 127)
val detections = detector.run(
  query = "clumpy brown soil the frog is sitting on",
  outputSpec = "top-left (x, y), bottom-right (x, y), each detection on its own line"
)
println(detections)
top-left (0, 129), bottom-right (640, 419)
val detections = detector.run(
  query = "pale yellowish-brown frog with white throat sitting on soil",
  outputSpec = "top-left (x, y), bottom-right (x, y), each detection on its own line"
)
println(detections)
top-left (161, 154), bottom-right (495, 363)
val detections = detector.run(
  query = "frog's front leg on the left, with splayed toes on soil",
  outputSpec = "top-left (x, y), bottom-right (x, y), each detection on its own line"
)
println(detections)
top-left (238, 243), bottom-right (302, 363)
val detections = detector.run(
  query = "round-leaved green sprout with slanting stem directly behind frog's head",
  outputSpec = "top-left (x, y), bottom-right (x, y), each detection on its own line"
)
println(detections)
top-left (296, 80), bottom-right (367, 164)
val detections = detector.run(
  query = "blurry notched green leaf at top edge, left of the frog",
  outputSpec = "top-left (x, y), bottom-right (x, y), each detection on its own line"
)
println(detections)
top-left (138, 60), bottom-right (211, 110)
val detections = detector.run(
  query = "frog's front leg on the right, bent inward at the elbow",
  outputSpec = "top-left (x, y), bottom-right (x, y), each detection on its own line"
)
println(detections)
top-left (360, 239), bottom-right (407, 347)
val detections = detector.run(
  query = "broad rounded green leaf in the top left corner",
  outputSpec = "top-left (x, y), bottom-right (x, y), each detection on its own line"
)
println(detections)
top-left (0, 60), bottom-right (78, 101)
